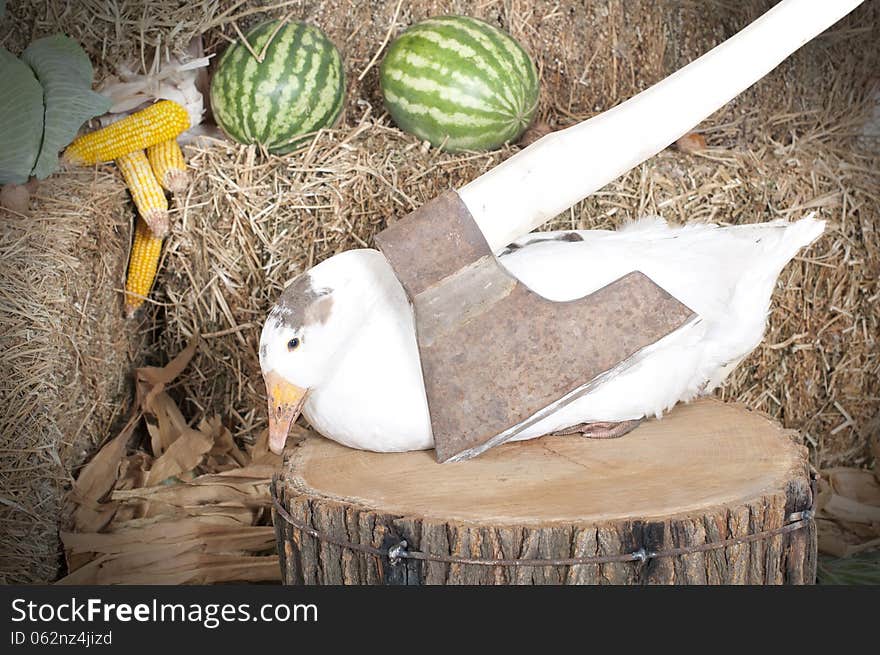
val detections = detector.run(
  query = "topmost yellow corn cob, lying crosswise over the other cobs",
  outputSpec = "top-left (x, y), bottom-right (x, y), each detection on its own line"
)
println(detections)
top-left (64, 100), bottom-right (189, 164)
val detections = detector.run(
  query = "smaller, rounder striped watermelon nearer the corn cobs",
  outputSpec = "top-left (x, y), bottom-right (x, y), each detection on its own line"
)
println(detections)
top-left (211, 21), bottom-right (345, 154)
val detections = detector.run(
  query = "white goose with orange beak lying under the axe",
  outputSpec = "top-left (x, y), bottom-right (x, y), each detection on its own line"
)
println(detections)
top-left (260, 217), bottom-right (824, 452)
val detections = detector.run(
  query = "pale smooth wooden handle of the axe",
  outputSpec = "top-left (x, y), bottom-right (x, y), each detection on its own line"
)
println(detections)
top-left (459, 0), bottom-right (862, 252)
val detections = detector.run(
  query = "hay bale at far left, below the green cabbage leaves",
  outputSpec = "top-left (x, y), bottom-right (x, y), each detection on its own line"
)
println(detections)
top-left (0, 171), bottom-right (137, 582)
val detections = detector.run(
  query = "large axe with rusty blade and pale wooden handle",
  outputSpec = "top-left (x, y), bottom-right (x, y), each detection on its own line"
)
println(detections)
top-left (376, 0), bottom-right (862, 462)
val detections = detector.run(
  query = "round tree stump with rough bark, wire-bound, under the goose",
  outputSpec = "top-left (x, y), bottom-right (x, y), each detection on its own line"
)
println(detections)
top-left (272, 400), bottom-right (816, 585)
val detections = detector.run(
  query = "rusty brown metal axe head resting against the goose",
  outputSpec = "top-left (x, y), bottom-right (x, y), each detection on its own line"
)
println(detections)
top-left (376, 191), bottom-right (696, 462)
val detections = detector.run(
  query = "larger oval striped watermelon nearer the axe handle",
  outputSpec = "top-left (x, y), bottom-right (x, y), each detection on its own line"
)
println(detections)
top-left (379, 16), bottom-right (539, 152)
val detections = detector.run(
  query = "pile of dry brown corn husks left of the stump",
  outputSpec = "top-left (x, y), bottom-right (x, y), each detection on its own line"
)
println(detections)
top-left (60, 339), bottom-right (280, 584)
